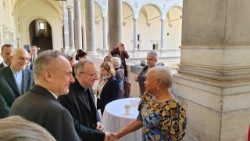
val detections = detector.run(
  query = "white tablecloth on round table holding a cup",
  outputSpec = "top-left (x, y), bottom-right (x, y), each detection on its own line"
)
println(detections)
top-left (102, 98), bottom-right (142, 141)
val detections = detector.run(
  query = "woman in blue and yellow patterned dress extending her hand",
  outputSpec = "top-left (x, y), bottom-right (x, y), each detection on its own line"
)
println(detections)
top-left (113, 67), bottom-right (186, 141)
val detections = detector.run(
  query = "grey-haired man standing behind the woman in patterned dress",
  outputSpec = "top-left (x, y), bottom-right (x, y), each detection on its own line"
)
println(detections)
top-left (135, 50), bottom-right (158, 96)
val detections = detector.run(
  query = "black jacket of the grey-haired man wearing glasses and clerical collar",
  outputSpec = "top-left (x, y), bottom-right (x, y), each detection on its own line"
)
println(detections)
top-left (58, 80), bottom-right (105, 141)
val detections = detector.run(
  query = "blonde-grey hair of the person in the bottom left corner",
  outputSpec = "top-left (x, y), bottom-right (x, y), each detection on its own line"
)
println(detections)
top-left (0, 116), bottom-right (56, 141)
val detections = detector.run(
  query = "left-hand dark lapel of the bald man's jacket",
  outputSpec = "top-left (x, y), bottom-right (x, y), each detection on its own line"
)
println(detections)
top-left (5, 66), bottom-right (20, 95)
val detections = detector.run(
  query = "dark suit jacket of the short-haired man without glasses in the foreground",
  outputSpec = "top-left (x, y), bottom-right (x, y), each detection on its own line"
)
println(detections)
top-left (10, 85), bottom-right (80, 141)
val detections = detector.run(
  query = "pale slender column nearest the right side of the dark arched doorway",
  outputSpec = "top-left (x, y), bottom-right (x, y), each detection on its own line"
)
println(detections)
top-left (63, 2), bottom-right (70, 52)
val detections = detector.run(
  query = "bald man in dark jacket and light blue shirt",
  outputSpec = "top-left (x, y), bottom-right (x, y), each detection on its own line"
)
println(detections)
top-left (0, 48), bottom-right (33, 118)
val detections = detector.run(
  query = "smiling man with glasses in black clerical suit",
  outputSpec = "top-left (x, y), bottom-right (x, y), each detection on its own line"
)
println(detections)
top-left (59, 60), bottom-right (108, 141)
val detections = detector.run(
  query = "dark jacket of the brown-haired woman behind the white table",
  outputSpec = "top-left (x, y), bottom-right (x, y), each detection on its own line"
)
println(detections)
top-left (97, 77), bottom-right (123, 113)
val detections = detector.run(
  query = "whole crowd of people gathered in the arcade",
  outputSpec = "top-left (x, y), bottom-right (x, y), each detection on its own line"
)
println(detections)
top-left (0, 43), bottom-right (186, 141)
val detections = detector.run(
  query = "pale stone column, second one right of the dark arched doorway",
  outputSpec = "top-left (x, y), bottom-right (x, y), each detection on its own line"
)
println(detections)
top-left (74, 0), bottom-right (82, 50)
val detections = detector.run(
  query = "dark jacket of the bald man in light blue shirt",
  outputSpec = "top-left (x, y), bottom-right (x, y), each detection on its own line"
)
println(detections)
top-left (0, 66), bottom-right (33, 118)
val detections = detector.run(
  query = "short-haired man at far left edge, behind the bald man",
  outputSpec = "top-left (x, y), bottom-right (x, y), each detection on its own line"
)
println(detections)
top-left (0, 44), bottom-right (13, 68)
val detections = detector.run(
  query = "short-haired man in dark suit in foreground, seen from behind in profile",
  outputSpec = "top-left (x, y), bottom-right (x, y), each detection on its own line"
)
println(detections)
top-left (10, 50), bottom-right (80, 141)
